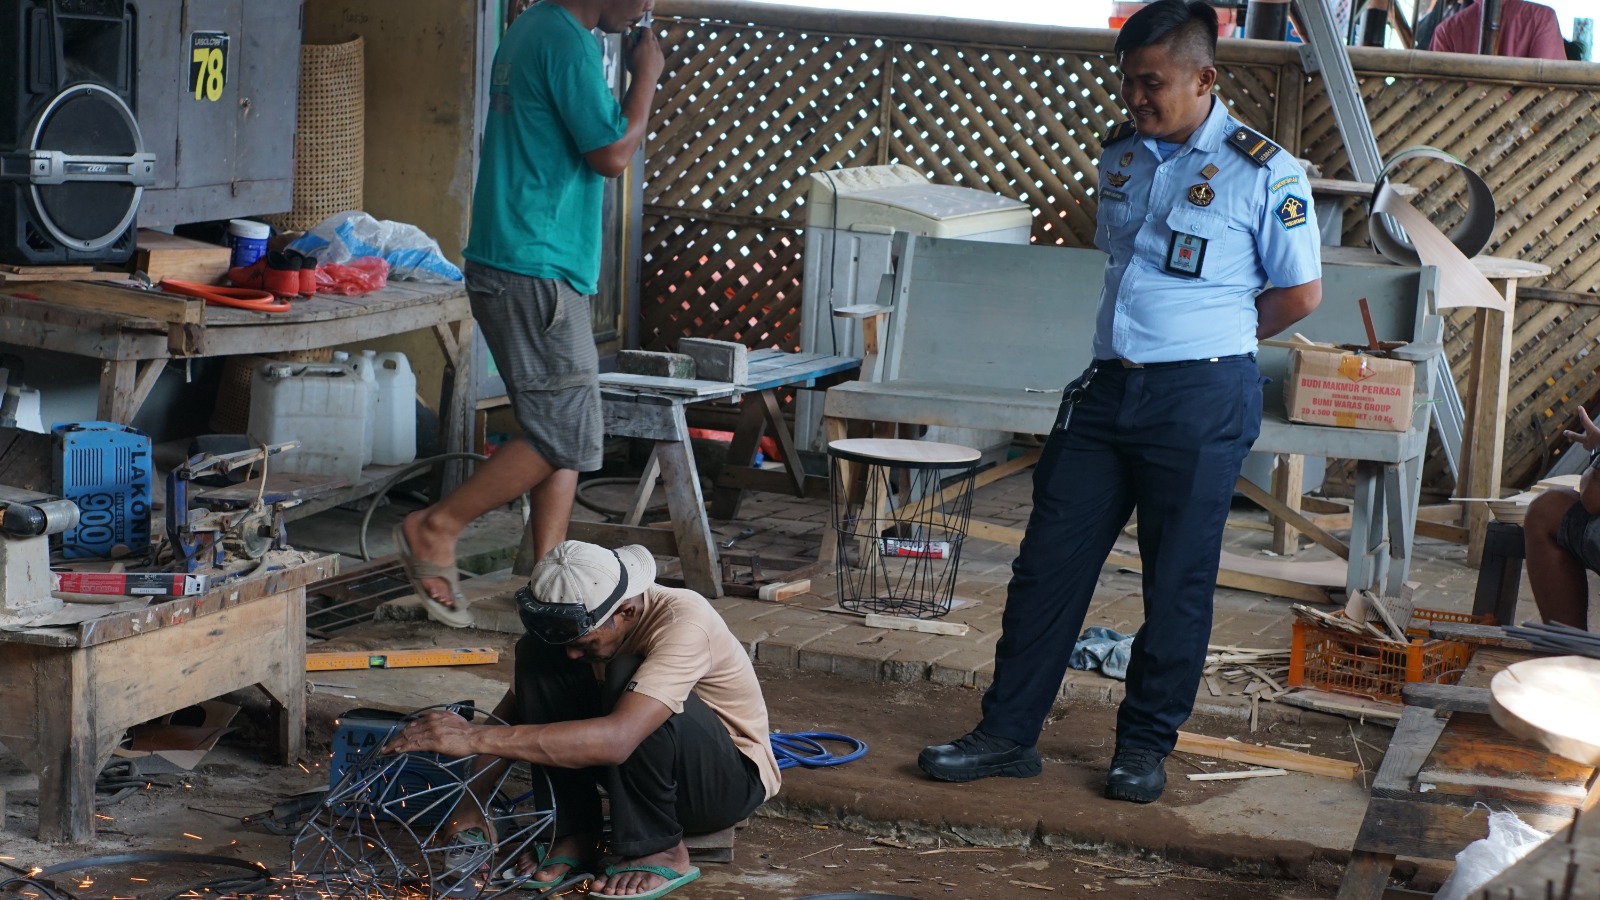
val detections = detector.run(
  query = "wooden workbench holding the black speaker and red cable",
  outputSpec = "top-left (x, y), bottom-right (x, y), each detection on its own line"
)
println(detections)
top-left (0, 282), bottom-right (474, 496)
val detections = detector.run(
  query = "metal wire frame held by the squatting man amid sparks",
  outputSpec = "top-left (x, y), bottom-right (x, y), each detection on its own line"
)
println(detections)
top-left (290, 705), bottom-right (555, 900)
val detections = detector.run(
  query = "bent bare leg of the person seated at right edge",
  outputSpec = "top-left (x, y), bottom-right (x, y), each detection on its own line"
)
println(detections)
top-left (1523, 488), bottom-right (1600, 628)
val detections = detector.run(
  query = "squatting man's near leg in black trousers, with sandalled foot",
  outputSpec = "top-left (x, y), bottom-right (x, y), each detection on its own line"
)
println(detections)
top-left (597, 657), bottom-right (766, 895)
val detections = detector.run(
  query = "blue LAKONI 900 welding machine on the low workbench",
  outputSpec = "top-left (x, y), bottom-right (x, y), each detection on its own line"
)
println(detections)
top-left (50, 421), bottom-right (154, 559)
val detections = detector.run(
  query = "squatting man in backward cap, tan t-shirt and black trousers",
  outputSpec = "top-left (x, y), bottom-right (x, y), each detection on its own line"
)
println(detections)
top-left (389, 541), bottom-right (779, 898)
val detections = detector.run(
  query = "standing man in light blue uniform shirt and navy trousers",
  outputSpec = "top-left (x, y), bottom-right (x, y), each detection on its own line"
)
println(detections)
top-left (918, 0), bottom-right (1322, 802)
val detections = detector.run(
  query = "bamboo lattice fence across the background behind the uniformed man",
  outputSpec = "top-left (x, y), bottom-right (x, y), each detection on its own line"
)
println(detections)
top-left (640, 0), bottom-right (1600, 484)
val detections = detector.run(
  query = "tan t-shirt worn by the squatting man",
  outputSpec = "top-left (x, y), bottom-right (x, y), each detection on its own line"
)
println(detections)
top-left (618, 585), bottom-right (781, 799)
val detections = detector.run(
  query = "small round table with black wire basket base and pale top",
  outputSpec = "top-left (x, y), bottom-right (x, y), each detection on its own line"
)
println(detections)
top-left (827, 439), bottom-right (979, 618)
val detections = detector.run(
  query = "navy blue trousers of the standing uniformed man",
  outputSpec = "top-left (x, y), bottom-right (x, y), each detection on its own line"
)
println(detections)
top-left (979, 357), bottom-right (1264, 753)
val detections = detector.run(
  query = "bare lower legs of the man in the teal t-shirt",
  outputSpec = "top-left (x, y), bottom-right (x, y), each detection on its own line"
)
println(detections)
top-left (400, 440), bottom-right (560, 607)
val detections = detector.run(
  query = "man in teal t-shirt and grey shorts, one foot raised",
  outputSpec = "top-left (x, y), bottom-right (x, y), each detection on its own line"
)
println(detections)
top-left (395, 0), bottom-right (662, 628)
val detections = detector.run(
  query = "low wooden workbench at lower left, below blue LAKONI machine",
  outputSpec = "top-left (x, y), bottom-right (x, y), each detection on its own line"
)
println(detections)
top-left (0, 557), bottom-right (339, 841)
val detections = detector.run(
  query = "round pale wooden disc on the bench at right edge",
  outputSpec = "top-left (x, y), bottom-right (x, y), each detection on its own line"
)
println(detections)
top-left (1490, 657), bottom-right (1600, 765)
